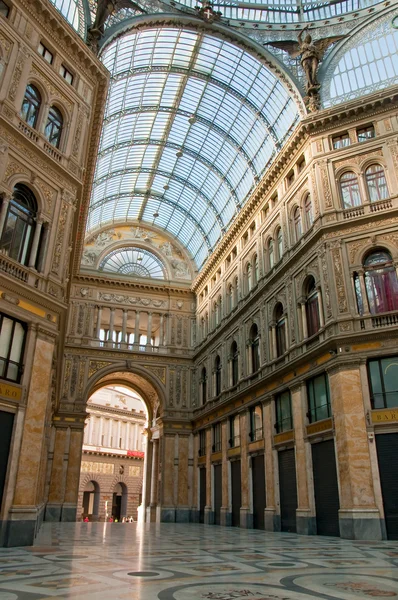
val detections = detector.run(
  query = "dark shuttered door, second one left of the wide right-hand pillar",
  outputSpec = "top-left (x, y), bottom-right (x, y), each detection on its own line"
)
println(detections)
top-left (278, 448), bottom-right (297, 533)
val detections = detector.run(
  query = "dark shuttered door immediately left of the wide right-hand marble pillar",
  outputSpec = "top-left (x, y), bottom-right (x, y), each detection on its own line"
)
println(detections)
top-left (312, 440), bottom-right (340, 536)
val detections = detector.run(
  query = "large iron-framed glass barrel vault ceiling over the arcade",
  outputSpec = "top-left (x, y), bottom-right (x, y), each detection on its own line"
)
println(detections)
top-left (87, 27), bottom-right (298, 268)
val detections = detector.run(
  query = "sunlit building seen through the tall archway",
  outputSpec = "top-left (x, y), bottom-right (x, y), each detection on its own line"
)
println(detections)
top-left (78, 385), bottom-right (148, 521)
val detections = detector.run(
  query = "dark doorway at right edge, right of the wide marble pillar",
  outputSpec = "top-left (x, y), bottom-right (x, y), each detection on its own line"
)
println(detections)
top-left (376, 433), bottom-right (398, 540)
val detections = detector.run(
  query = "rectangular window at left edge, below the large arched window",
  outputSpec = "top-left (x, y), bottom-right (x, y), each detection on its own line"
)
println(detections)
top-left (0, 313), bottom-right (27, 383)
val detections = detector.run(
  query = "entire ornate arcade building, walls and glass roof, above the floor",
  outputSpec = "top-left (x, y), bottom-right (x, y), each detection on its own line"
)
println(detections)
top-left (0, 0), bottom-right (398, 546)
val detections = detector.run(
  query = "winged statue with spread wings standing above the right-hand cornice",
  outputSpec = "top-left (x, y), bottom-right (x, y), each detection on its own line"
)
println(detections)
top-left (266, 25), bottom-right (345, 112)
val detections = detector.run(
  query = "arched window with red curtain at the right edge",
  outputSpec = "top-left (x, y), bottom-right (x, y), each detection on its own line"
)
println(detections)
top-left (356, 250), bottom-right (398, 314)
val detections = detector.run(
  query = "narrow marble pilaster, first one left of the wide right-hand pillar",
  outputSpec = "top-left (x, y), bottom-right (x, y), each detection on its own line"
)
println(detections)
top-left (290, 382), bottom-right (316, 535)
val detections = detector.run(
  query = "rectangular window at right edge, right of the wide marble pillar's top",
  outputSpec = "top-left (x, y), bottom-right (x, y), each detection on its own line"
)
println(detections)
top-left (368, 356), bottom-right (398, 408)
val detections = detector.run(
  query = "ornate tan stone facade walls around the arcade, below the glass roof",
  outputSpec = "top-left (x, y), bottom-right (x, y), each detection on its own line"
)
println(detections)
top-left (0, 0), bottom-right (398, 545)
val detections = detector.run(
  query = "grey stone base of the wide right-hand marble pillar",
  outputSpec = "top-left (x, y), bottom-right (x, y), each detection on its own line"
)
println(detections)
top-left (339, 508), bottom-right (386, 540)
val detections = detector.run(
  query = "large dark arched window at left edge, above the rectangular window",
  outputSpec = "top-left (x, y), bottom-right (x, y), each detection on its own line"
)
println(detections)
top-left (0, 183), bottom-right (37, 265)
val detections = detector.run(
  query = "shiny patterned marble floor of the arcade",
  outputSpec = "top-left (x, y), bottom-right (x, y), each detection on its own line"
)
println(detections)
top-left (0, 523), bottom-right (398, 600)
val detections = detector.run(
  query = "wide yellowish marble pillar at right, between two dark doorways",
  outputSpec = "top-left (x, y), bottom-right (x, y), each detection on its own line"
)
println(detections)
top-left (328, 363), bottom-right (382, 540)
